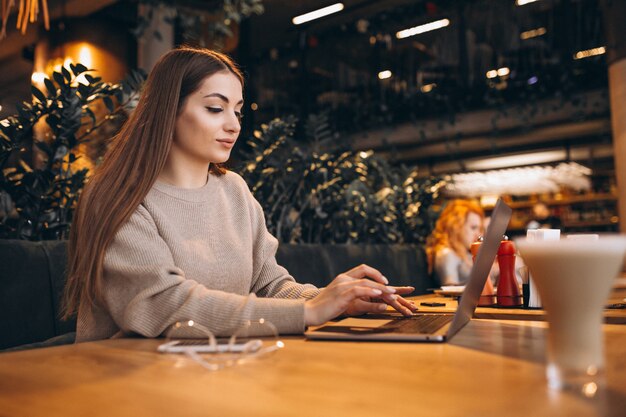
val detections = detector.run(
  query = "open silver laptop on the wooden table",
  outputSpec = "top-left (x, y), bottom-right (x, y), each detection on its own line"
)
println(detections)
top-left (304, 200), bottom-right (512, 342)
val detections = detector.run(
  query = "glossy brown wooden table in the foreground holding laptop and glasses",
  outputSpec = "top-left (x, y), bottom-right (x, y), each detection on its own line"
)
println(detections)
top-left (0, 320), bottom-right (626, 417)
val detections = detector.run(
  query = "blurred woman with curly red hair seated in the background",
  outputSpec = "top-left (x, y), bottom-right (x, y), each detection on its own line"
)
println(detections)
top-left (426, 200), bottom-right (485, 285)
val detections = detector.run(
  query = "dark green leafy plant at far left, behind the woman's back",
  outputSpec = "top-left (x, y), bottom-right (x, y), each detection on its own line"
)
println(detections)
top-left (0, 64), bottom-right (145, 240)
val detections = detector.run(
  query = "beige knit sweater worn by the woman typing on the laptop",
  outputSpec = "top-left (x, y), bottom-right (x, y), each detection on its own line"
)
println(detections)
top-left (77, 172), bottom-right (319, 342)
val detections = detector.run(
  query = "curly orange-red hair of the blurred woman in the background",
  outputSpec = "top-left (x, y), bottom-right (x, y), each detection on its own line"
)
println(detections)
top-left (426, 200), bottom-right (485, 272)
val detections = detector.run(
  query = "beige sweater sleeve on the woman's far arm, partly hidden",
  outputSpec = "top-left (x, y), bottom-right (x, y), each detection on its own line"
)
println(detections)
top-left (244, 183), bottom-right (320, 299)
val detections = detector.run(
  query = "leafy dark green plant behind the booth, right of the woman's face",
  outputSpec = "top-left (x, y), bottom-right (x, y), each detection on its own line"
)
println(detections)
top-left (239, 116), bottom-right (445, 243)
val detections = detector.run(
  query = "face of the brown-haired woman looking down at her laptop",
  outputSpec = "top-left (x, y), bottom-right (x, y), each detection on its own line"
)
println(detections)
top-left (170, 71), bottom-right (243, 164)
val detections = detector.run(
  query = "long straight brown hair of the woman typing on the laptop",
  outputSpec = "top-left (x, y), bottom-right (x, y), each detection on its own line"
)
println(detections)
top-left (63, 47), bottom-right (243, 319)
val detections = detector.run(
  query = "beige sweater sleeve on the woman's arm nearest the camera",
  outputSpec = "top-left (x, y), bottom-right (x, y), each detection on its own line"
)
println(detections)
top-left (102, 205), bottom-right (312, 337)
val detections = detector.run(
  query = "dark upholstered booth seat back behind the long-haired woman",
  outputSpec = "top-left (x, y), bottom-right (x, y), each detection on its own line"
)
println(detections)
top-left (0, 239), bottom-right (434, 350)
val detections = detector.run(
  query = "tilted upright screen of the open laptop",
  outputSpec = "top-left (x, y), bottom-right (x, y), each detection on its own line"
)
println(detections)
top-left (447, 199), bottom-right (512, 339)
